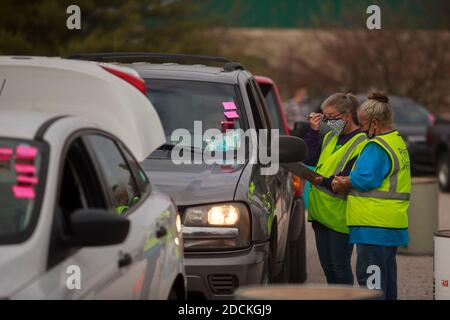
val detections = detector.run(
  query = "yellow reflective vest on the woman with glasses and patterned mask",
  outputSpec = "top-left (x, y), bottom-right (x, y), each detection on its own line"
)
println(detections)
top-left (308, 132), bottom-right (367, 233)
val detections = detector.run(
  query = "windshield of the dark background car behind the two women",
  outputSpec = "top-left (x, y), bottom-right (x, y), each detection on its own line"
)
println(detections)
top-left (390, 98), bottom-right (430, 126)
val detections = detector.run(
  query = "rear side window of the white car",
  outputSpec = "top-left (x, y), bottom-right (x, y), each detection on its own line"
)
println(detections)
top-left (86, 135), bottom-right (140, 214)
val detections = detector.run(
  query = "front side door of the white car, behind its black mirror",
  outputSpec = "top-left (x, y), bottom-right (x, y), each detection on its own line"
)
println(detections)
top-left (22, 136), bottom-right (125, 299)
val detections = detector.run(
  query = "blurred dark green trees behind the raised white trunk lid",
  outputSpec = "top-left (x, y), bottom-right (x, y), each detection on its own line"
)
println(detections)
top-left (0, 0), bottom-right (221, 55)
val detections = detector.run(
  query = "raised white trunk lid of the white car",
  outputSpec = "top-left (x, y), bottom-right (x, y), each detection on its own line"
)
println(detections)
top-left (0, 57), bottom-right (165, 161)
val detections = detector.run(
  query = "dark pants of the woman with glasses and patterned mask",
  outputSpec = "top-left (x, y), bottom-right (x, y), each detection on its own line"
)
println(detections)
top-left (312, 221), bottom-right (353, 285)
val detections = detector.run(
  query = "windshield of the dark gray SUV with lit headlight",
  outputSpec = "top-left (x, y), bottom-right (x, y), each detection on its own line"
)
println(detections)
top-left (147, 79), bottom-right (246, 151)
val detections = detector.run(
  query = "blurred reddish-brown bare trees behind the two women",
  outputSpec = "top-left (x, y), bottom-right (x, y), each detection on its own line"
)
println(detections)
top-left (273, 30), bottom-right (450, 111)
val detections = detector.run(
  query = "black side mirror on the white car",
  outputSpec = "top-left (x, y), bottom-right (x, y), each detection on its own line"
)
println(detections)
top-left (70, 209), bottom-right (130, 247)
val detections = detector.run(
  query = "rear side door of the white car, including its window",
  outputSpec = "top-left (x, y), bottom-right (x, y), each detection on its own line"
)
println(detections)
top-left (84, 134), bottom-right (167, 299)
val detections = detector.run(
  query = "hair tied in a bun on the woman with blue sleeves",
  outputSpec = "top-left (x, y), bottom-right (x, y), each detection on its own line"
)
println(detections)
top-left (358, 92), bottom-right (393, 125)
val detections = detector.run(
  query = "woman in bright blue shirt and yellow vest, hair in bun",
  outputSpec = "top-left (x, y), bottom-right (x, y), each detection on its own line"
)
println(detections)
top-left (332, 93), bottom-right (411, 300)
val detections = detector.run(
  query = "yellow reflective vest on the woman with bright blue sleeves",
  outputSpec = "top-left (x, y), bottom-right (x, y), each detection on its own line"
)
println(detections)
top-left (347, 131), bottom-right (411, 229)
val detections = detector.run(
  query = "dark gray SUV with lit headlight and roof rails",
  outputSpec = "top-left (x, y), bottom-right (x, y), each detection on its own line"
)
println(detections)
top-left (71, 53), bottom-right (307, 299)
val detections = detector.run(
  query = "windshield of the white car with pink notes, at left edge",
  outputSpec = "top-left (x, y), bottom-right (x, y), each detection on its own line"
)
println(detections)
top-left (0, 138), bottom-right (42, 243)
